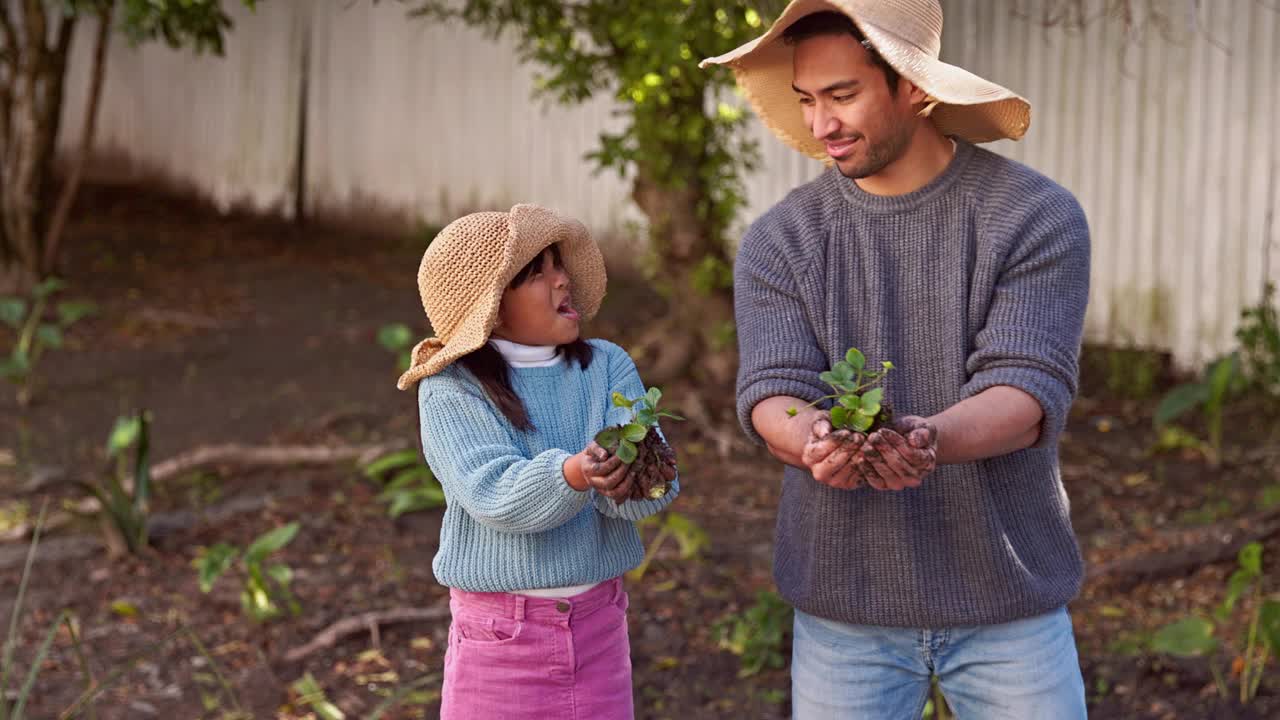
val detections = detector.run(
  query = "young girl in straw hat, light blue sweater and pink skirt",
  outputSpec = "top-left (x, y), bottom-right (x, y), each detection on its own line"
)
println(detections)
top-left (398, 205), bottom-right (680, 720)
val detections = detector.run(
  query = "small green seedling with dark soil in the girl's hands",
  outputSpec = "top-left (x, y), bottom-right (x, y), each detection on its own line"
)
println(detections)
top-left (595, 387), bottom-right (684, 500)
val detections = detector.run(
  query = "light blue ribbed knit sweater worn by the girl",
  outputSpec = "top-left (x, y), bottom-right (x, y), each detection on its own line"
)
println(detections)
top-left (417, 340), bottom-right (680, 592)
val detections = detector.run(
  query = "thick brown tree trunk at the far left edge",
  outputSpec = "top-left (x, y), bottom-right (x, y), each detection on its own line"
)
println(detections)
top-left (0, 0), bottom-right (76, 288)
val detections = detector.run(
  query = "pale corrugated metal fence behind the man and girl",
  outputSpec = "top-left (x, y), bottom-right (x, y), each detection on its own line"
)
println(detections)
top-left (63, 0), bottom-right (1280, 365)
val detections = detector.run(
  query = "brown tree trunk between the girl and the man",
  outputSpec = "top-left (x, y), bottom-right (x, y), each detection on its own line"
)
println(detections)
top-left (631, 168), bottom-right (736, 384)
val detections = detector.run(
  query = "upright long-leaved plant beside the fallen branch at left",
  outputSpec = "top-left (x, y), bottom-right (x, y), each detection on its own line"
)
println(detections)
top-left (77, 411), bottom-right (151, 555)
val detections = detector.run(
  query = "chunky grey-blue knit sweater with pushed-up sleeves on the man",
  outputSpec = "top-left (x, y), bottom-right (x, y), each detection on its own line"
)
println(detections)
top-left (735, 142), bottom-right (1089, 629)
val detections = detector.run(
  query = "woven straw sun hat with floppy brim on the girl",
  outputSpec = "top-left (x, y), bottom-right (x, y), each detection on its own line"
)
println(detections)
top-left (396, 205), bottom-right (605, 389)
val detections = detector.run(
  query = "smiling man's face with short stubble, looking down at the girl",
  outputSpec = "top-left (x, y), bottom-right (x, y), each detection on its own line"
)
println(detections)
top-left (792, 33), bottom-right (915, 179)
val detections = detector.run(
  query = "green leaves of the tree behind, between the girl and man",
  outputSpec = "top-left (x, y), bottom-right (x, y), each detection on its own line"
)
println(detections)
top-left (411, 0), bottom-right (785, 272)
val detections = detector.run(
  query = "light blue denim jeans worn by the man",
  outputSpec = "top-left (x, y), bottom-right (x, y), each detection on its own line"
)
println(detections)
top-left (791, 607), bottom-right (1087, 720)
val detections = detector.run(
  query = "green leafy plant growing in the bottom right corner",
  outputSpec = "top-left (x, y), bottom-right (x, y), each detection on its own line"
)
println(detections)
top-left (1151, 542), bottom-right (1280, 703)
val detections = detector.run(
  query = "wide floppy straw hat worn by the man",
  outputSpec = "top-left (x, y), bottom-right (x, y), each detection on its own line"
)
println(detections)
top-left (700, 0), bottom-right (1032, 159)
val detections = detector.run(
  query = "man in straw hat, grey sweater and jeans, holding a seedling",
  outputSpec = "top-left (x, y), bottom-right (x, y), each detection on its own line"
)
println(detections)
top-left (704, 0), bottom-right (1089, 720)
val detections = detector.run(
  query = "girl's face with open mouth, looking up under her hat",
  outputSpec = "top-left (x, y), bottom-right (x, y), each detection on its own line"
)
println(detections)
top-left (493, 245), bottom-right (579, 345)
